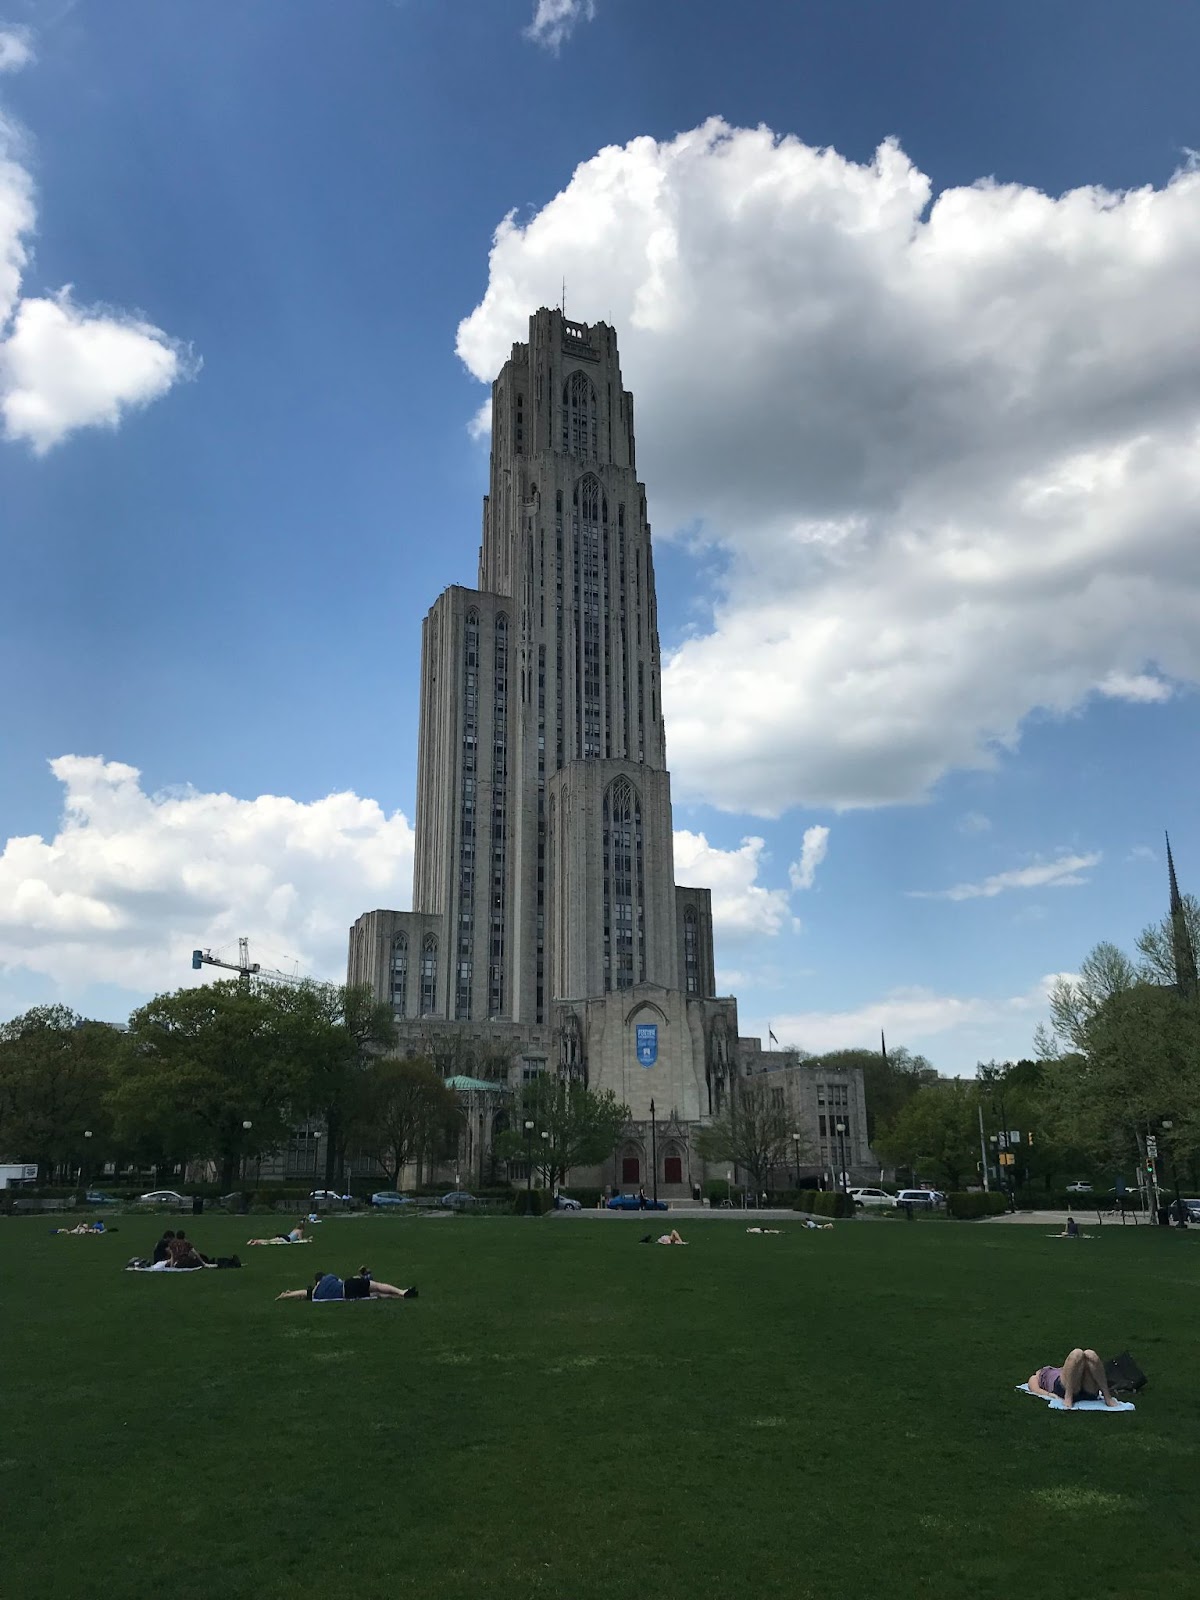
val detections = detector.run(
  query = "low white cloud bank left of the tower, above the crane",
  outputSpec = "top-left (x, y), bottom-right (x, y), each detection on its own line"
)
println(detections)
top-left (0, 755), bottom-right (413, 992)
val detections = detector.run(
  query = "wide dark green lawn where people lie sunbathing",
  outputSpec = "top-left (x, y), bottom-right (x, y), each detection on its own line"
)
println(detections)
top-left (0, 1216), bottom-right (1200, 1600)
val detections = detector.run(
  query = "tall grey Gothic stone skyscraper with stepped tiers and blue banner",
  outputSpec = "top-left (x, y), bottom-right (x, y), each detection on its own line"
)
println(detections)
top-left (349, 318), bottom-right (736, 1184)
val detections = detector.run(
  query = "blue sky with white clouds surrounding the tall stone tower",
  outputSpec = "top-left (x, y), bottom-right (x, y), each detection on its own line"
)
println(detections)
top-left (0, 0), bottom-right (1200, 1072)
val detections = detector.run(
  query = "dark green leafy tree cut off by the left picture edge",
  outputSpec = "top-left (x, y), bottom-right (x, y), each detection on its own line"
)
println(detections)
top-left (0, 1005), bottom-right (123, 1182)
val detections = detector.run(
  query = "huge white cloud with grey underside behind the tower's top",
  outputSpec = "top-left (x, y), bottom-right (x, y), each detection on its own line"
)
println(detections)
top-left (458, 118), bottom-right (1200, 814)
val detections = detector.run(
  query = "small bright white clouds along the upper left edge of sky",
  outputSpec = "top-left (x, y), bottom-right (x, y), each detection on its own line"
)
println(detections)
top-left (0, 43), bottom-right (197, 454)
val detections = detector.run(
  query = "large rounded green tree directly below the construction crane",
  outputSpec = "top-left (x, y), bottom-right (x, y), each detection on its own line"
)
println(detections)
top-left (109, 981), bottom-right (307, 1187)
